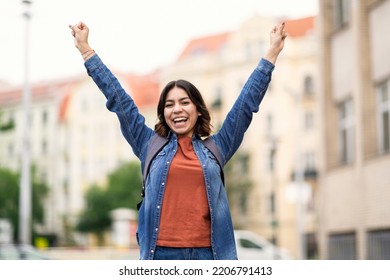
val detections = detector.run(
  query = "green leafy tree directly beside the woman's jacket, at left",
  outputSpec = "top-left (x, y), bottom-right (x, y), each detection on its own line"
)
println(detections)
top-left (76, 162), bottom-right (142, 245)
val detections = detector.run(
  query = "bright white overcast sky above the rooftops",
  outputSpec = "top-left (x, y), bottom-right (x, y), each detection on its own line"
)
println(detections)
top-left (0, 0), bottom-right (318, 85)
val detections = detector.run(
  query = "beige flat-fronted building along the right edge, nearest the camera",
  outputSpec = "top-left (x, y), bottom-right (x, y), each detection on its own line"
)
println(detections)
top-left (318, 0), bottom-right (390, 259)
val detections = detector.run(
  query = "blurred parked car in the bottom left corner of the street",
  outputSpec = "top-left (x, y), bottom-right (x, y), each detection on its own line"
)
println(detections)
top-left (0, 243), bottom-right (49, 260)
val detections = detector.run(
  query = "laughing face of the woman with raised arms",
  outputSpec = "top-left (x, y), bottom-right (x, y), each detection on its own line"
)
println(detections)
top-left (164, 87), bottom-right (200, 137)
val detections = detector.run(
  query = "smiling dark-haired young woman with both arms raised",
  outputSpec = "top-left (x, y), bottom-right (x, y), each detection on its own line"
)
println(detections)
top-left (69, 22), bottom-right (286, 260)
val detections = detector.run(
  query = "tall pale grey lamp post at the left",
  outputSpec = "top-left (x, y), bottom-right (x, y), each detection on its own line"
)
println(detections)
top-left (19, 0), bottom-right (32, 244)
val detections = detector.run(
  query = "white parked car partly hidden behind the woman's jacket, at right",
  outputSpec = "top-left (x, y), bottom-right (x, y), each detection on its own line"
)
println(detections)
top-left (234, 230), bottom-right (292, 260)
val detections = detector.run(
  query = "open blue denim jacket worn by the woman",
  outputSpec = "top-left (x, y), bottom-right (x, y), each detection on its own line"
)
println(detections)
top-left (85, 55), bottom-right (274, 260)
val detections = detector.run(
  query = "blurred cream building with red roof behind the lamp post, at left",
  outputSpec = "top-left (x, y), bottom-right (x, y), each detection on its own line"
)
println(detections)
top-left (0, 73), bottom-right (159, 244)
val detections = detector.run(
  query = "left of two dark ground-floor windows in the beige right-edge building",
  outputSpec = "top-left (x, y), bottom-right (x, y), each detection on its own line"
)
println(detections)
top-left (328, 233), bottom-right (356, 260)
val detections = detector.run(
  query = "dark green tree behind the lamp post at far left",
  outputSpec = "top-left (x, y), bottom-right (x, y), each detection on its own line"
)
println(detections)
top-left (0, 168), bottom-right (48, 240)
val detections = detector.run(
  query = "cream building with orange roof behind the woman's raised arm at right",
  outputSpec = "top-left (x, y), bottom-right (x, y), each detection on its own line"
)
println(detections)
top-left (160, 15), bottom-right (320, 258)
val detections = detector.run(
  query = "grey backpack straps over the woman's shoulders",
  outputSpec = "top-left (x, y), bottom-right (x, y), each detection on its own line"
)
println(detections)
top-left (137, 133), bottom-right (225, 210)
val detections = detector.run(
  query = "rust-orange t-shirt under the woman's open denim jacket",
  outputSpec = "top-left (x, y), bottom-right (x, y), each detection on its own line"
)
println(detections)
top-left (157, 137), bottom-right (211, 247)
